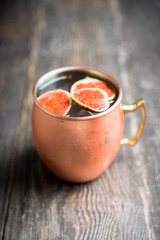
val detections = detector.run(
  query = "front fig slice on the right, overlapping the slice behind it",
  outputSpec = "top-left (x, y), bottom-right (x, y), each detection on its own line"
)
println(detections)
top-left (71, 88), bottom-right (110, 112)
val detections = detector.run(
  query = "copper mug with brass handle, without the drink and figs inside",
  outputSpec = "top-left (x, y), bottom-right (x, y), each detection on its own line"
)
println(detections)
top-left (32, 67), bottom-right (146, 183)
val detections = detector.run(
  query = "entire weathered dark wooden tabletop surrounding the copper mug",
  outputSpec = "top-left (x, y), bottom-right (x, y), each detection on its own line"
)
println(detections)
top-left (0, 0), bottom-right (160, 240)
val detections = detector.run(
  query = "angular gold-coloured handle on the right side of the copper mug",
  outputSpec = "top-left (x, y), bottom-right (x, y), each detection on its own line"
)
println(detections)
top-left (120, 99), bottom-right (147, 146)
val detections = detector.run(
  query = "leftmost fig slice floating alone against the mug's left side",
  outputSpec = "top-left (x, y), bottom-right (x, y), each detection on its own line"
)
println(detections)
top-left (37, 89), bottom-right (72, 116)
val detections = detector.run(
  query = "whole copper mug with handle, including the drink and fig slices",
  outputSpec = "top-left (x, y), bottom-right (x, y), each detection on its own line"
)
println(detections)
top-left (32, 67), bottom-right (146, 182)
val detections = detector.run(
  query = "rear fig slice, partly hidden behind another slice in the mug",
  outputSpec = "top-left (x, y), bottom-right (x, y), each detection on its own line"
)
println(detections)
top-left (70, 77), bottom-right (116, 100)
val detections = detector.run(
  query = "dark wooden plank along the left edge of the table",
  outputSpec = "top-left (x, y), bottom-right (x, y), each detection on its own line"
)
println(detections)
top-left (0, 0), bottom-right (35, 237)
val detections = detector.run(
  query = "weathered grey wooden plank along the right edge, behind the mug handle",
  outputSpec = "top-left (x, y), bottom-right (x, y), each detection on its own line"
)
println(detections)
top-left (117, 1), bottom-right (160, 239)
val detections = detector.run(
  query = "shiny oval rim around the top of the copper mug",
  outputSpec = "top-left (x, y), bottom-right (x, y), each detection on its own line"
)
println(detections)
top-left (32, 66), bottom-right (122, 121)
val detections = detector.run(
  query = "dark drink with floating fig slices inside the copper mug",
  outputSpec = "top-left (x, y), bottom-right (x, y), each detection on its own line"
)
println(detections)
top-left (37, 75), bottom-right (117, 117)
